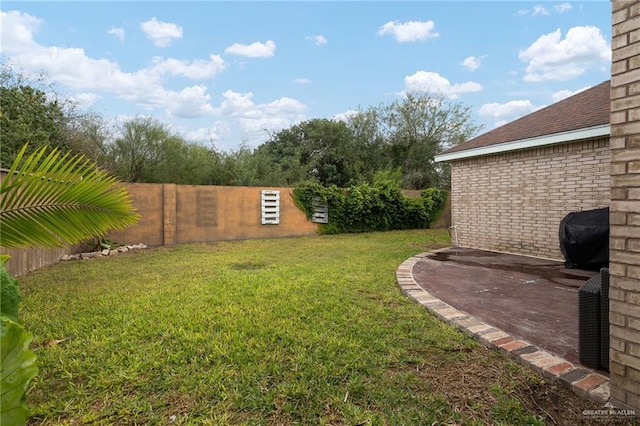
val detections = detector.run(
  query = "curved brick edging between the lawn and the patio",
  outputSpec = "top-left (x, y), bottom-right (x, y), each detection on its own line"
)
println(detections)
top-left (396, 249), bottom-right (611, 406)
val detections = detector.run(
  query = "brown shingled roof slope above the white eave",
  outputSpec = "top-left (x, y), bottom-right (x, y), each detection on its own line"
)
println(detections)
top-left (442, 80), bottom-right (611, 154)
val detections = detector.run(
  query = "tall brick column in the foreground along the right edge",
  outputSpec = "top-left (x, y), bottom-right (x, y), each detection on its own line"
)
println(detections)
top-left (609, 1), bottom-right (640, 409)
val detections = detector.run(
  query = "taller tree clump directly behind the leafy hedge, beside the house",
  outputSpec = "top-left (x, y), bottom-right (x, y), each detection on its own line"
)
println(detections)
top-left (256, 94), bottom-right (479, 189)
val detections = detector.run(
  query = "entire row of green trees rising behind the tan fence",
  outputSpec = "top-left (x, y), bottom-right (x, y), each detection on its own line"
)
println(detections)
top-left (0, 66), bottom-right (479, 189)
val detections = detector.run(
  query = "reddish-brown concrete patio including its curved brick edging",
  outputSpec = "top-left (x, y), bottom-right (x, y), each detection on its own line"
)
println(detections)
top-left (396, 248), bottom-right (610, 404)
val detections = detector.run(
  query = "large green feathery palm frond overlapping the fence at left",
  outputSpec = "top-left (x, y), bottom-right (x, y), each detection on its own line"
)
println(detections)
top-left (0, 145), bottom-right (139, 248)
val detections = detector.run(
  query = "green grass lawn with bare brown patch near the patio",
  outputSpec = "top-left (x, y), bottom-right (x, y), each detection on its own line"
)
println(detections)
top-left (20, 230), bottom-right (597, 425)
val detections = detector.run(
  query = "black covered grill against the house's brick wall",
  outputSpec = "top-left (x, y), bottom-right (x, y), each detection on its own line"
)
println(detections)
top-left (559, 207), bottom-right (609, 270)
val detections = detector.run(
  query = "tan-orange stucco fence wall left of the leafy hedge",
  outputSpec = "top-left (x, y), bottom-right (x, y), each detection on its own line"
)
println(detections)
top-left (0, 183), bottom-right (317, 276)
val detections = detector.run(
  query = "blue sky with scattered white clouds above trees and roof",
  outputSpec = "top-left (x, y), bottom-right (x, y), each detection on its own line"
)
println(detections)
top-left (0, 1), bottom-right (611, 152)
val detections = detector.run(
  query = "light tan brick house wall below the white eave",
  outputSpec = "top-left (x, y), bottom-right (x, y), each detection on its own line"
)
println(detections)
top-left (451, 138), bottom-right (610, 260)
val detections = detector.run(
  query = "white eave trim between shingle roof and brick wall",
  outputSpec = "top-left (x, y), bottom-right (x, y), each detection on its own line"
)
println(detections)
top-left (434, 124), bottom-right (611, 163)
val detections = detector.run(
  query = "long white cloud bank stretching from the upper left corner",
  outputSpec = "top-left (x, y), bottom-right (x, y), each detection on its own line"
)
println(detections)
top-left (2, 13), bottom-right (226, 117)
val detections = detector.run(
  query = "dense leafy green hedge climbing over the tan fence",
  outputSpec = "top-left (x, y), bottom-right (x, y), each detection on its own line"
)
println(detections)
top-left (293, 182), bottom-right (447, 234)
